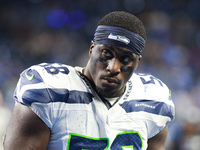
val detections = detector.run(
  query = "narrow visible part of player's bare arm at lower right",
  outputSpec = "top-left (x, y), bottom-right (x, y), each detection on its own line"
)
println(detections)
top-left (147, 126), bottom-right (168, 150)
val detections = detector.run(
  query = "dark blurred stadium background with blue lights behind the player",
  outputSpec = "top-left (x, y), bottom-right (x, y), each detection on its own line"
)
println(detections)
top-left (0, 0), bottom-right (200, 150)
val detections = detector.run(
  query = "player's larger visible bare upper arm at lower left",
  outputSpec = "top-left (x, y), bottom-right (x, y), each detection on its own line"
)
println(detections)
top-left (4, 103), bottom-right (50, 150)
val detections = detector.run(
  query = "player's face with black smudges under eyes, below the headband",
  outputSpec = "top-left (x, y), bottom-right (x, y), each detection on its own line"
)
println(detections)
top-left (87, 43), bottom-right (141, 98)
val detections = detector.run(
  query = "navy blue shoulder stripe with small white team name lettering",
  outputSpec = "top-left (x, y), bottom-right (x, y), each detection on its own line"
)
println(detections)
top-left (120, 100), bottom-right (174, 119)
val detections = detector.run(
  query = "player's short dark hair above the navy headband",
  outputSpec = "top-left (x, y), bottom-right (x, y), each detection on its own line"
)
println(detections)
top-left (98, 11), bottom-right (146, 40)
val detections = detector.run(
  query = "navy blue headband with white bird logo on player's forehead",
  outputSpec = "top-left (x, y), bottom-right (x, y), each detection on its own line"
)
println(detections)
top-left (94, 25), bottom-right (145, 55)
